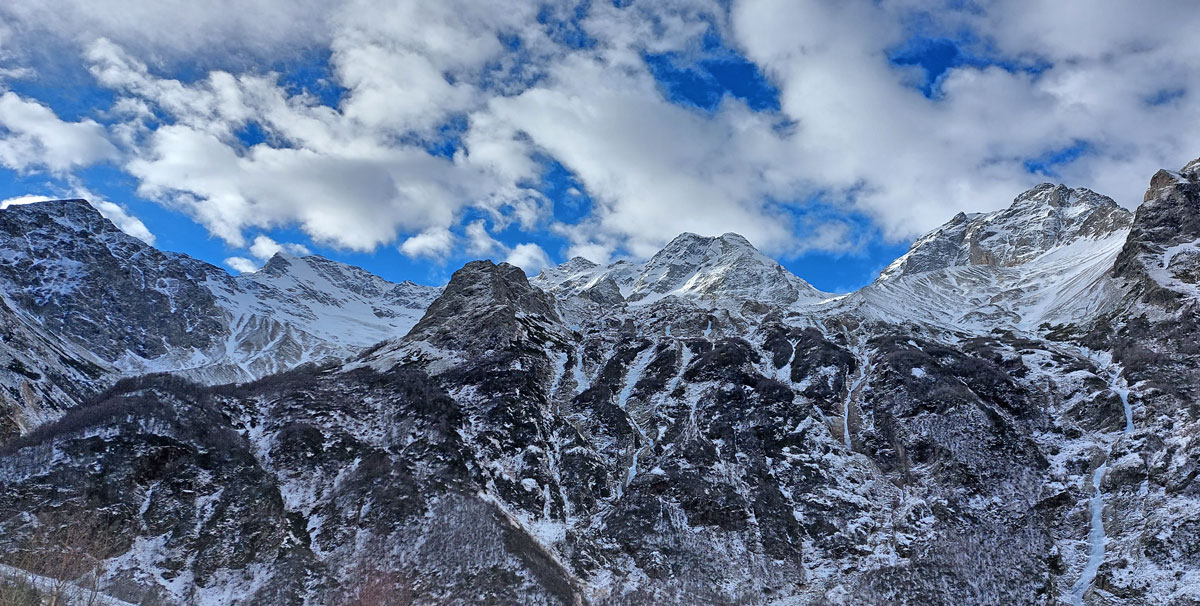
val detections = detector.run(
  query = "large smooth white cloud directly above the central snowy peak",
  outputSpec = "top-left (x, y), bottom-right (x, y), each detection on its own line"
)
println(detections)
top-left (472, 53), bottom-right (796, 256)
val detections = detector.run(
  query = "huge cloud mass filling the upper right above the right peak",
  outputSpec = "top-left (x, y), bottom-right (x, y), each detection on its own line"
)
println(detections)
top-left (733, 0), bottom-right (1200, 238)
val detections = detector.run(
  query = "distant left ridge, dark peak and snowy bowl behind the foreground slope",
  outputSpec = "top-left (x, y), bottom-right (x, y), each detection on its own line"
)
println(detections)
top-left (0, 200), bottom-right (440, 383)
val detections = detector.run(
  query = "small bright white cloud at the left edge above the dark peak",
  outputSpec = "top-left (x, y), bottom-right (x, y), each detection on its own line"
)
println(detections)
top-left (0, 92), bottom-right (116, 173)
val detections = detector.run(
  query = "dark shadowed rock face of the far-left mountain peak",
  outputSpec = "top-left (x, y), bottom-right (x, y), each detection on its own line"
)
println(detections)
top-left (0, 200), bottom-right (232, 362)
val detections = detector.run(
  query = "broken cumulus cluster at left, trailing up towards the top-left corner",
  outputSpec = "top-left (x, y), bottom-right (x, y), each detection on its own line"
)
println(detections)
top-left (88, 33), bottom-right (545, 251)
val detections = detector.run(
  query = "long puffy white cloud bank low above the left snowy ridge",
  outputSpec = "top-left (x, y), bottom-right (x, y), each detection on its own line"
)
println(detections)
top-left (127, 126), bottom-right (484, 251)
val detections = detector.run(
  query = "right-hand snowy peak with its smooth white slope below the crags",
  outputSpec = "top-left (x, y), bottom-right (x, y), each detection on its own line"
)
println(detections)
top-left (840, 184), bottom-right (1133, 334)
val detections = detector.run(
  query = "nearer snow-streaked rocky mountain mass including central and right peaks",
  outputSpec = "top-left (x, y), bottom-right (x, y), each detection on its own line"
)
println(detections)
top-left (0, 162), bottom-right (1200, 605)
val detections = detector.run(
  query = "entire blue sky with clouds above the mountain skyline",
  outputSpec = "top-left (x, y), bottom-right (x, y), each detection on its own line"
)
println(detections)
top-left (0, 0), bottom-right (1200, 292)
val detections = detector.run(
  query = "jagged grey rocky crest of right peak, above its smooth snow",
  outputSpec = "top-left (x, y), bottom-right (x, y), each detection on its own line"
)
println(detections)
top-left (880, 184), bottom-right (1133, 280)
